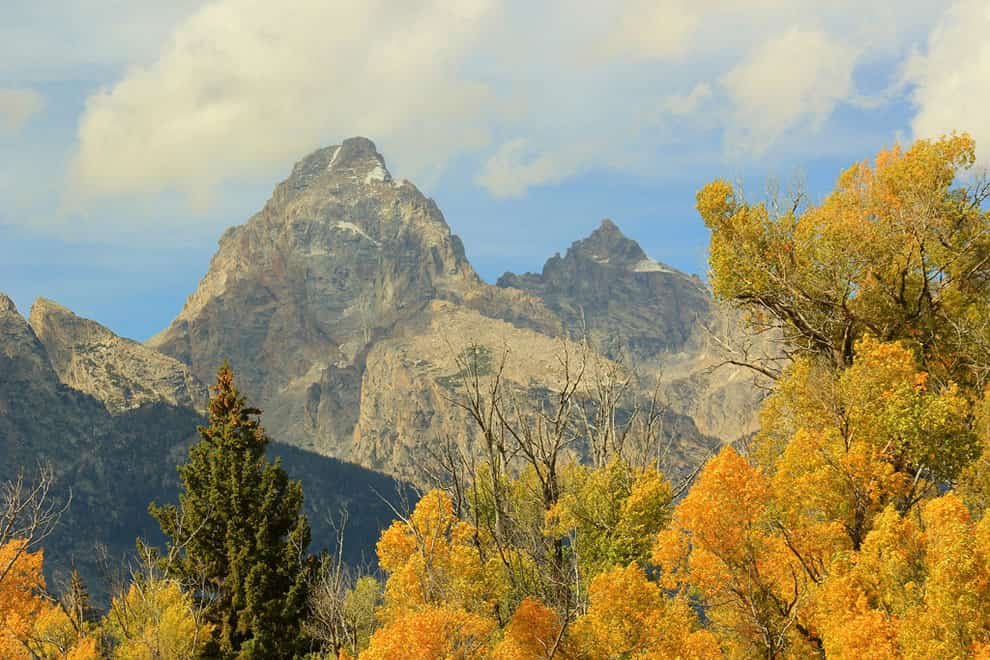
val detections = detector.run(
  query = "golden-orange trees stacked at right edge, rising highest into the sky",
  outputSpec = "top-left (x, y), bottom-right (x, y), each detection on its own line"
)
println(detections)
top-left (654, 135), bottom-right (990, 657)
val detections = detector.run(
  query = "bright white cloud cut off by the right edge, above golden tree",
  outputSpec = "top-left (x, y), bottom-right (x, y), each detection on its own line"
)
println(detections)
top-left (907, 0), bottom-right (990, 166)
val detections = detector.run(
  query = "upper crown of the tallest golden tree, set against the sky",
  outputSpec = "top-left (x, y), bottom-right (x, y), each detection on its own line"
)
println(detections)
top-left (697, 135), bottom-right (990, 390)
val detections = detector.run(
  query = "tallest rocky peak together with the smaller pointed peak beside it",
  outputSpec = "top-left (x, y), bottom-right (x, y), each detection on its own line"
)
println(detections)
top-left (147, 138), bottom-right (752, 481)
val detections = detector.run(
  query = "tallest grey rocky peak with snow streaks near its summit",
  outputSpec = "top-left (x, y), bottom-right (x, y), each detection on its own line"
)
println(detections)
top-left (148, 138), bottom-right (479, 455)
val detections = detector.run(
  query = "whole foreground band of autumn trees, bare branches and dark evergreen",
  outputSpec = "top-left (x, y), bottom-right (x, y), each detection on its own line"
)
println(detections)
top-left (0, 134), bottom-right (990, 660)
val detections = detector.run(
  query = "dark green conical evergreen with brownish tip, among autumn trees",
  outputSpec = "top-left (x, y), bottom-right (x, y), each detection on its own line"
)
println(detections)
top-left (150, 363), bottom-right (310, 658)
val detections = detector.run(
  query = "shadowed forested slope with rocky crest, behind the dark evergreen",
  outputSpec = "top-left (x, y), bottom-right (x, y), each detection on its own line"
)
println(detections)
top-left (0, 294), bottom-right (407, 598)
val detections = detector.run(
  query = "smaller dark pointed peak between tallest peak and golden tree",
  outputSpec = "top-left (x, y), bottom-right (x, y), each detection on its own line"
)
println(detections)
top-left (497, 219), bottom-right (772, 442)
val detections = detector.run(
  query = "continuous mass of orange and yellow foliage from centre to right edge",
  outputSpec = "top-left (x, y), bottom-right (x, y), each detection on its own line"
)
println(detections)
top-left (371, 135), bottom-right (990, 658)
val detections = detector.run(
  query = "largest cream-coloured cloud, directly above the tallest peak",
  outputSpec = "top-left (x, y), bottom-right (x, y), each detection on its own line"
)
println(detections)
top-left (73, 0), bottom-right (493, 198)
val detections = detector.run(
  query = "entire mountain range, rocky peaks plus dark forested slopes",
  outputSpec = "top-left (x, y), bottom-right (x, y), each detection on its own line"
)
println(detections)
top-left (0, 138), bottom-right (760, 589)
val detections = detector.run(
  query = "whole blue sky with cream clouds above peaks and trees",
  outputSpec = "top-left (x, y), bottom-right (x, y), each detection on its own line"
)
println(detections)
top-left (0, 0), bottom-right (990, 340)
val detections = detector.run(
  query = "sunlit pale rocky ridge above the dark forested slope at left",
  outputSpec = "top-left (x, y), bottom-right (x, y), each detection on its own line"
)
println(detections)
top-left (29, 298), bottom-right (209, 414)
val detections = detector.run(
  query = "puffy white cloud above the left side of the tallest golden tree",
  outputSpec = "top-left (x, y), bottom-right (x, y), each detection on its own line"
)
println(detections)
top-left (721, 28), bottom-right (857, 154)
